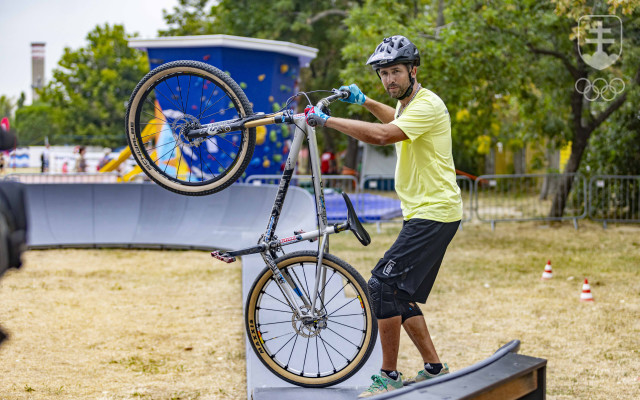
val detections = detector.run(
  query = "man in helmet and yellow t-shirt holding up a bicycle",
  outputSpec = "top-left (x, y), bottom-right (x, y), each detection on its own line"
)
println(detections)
top-left (305, 36), bottom-right (462, 397)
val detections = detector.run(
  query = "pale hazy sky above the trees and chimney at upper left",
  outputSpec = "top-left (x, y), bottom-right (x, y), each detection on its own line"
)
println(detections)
top-left (0, 0), bottom-right (178, 104)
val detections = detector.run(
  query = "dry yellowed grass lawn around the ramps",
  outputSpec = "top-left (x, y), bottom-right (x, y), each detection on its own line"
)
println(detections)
top-left (0, 222), bottom-right (640, 399)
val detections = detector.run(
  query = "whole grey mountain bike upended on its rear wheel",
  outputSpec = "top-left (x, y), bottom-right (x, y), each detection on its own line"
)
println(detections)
top-left (125, 61), bottom-right (377, 387)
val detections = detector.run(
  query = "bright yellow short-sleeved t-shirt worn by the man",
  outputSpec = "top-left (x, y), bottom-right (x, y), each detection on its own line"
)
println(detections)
top-left (391, 89), bottom-right (462, 222)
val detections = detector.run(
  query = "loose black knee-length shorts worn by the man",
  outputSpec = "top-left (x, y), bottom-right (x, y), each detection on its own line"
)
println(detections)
top-left (371, 219), bottom-right (460, 303)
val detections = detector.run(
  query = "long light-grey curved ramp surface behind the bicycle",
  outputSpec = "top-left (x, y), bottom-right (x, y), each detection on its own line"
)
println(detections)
top-left (26, 184), bottom-right (316, 250)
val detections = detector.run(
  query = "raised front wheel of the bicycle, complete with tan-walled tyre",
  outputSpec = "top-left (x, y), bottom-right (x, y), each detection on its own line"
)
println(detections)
top-left (125, 61), bottom-right (256, 195)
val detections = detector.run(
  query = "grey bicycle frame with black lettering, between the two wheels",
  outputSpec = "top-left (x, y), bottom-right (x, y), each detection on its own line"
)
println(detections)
top-left (218, 113), bottom-right (348, 319)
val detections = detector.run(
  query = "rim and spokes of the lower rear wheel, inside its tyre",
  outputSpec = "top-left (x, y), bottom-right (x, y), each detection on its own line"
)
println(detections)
top-left (254, 259), bottom-right (371, 384)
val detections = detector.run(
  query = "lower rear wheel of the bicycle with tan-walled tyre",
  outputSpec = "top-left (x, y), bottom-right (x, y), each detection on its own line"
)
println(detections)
top-left (245, 251), bottom-right (378, 387)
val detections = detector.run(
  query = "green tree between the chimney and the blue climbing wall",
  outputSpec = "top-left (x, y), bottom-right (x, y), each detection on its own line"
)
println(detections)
top-left (39, 24), bottom-right (149, 147)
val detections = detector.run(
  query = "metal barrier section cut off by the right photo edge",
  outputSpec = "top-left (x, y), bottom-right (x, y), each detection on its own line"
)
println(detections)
top-left (588, 175), bottom-right (640, 229)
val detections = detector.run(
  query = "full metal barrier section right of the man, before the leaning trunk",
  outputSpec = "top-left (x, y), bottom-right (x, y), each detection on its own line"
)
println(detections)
top-left (474, 174), bottom-right (587, 230)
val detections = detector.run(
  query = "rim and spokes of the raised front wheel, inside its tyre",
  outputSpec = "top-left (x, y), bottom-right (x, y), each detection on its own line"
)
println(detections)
top-left (135, 69), bottom-right (249, 191)
